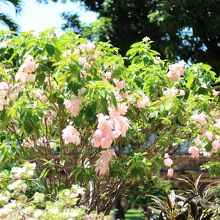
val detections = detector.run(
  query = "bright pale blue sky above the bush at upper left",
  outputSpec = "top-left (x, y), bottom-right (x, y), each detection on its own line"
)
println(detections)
top-left (0, 0), bottom-right (96, 33)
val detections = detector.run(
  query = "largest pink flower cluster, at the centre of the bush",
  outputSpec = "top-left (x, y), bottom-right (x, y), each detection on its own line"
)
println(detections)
top-left (92, 104), bottom-right (129, 149)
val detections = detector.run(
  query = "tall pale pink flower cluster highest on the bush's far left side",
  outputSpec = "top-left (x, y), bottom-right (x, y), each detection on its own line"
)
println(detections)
top-left (15, 55), bottom-right (38, 83)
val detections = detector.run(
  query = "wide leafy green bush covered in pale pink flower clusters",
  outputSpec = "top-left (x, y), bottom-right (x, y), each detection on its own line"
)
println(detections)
top-left (0, 31), bottom-right (220, 212)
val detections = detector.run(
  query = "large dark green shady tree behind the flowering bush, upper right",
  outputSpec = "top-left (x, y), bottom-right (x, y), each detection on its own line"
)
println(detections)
top-left (38, 0), bottom-right (220, 73)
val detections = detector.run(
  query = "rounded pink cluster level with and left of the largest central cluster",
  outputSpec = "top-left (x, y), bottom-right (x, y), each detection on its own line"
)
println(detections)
top-left (62, 125), bottom-right (80, 145)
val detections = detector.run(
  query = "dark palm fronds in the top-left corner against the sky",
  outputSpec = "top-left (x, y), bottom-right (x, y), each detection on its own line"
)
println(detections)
top-left (0, 0), bottom-right (22, 31)
